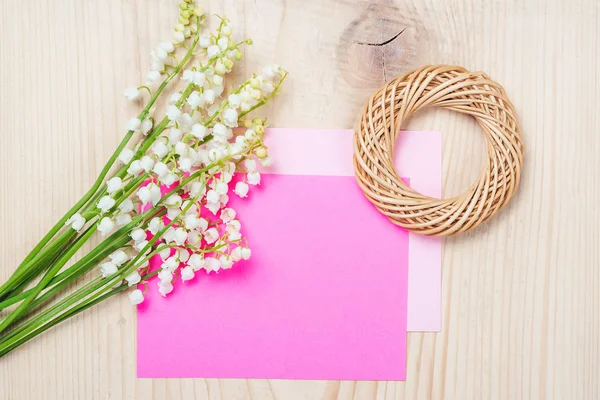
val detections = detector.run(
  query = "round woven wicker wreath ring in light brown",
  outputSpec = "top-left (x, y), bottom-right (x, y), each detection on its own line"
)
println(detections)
top-left (354, 65), bottom-right (524, 236)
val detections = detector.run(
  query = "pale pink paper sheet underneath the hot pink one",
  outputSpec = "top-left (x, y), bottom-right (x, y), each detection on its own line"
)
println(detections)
top-left (264, 129), bottom-right (442, 332)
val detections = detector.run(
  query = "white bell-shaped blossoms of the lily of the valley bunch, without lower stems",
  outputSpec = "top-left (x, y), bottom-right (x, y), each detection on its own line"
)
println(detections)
top-left (62, 0), bottom-right (286, 304)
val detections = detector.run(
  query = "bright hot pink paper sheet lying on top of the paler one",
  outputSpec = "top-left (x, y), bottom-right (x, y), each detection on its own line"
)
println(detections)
top-left (138, 173), bottom-right (408, 380)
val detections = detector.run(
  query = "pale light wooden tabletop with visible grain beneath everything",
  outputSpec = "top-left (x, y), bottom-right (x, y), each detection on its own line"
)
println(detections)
top-left (0, 0), bottom-right (600, 400)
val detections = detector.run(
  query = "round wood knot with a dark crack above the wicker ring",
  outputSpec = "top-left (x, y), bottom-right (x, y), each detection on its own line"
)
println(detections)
top-left (337, 4), bottom-right (432, 88)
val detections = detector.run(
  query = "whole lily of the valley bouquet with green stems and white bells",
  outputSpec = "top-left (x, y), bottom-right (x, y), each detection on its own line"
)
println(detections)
top-left (0, 0), bottom-right (286, 357)
